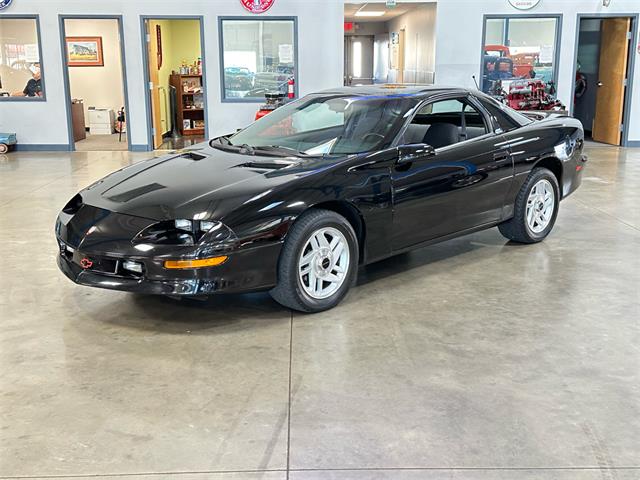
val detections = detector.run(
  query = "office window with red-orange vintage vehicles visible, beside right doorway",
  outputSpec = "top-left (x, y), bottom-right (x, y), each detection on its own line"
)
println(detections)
top-left (481, 17), bottom-right (559, 94)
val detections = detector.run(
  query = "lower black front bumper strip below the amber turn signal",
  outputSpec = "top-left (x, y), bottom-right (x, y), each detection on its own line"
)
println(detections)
top-left (58, 243), bottom-right (281, 296)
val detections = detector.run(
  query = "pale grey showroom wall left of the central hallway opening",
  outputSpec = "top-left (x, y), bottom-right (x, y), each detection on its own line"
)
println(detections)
top-left (0, 0), bottom-right (344, 150)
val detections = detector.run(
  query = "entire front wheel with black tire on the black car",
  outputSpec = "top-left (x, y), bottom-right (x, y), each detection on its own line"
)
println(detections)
top-left (270, 209), bottom-right (359, 313)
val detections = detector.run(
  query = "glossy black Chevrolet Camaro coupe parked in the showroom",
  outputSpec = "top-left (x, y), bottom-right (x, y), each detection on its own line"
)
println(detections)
top-left (56, 85), bottom-right (586, 312)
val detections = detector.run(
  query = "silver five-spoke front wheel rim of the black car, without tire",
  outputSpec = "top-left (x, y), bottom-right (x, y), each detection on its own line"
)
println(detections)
top-left (298, 227), bottom-right (350, 300)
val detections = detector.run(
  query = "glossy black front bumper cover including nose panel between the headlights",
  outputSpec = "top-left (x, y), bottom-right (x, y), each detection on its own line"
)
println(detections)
top-left (56, 205), bottom-right (282, 296)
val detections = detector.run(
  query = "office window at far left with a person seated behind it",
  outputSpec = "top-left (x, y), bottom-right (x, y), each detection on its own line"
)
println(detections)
top-left (0, 17), bottom-right (44, 100)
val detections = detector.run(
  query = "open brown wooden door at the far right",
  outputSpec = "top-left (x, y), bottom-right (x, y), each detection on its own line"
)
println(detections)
top-left (592, 18), bottom-right (631, 145)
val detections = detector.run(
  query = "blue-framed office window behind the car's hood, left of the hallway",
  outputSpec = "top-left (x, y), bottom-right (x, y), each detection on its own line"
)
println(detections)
top-left (221, 19), bottom-right (297, 101)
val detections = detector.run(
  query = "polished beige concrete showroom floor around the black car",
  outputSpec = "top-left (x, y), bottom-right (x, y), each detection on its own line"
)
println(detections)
top-left (0, 145), bottom-right (640, 480)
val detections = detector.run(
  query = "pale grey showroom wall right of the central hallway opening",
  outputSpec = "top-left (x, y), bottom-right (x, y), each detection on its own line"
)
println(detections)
top-left (436, 0), bottom-right (640, 144)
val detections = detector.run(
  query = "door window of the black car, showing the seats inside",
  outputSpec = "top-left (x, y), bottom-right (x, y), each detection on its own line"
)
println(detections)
top-left (402, 98), bottom-right (489, 148)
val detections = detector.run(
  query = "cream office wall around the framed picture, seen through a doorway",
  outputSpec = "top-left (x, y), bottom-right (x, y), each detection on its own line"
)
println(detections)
top-left (65, 19), bottom-right (124, 119)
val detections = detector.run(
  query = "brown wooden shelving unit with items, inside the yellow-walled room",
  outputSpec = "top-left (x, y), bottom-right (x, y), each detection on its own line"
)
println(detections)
top-left (169, 74), bottom-right (205, 135)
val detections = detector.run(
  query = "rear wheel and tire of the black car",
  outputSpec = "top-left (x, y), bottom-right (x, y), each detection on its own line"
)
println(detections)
top-left (498, 168), bottom-right (560, 243)
